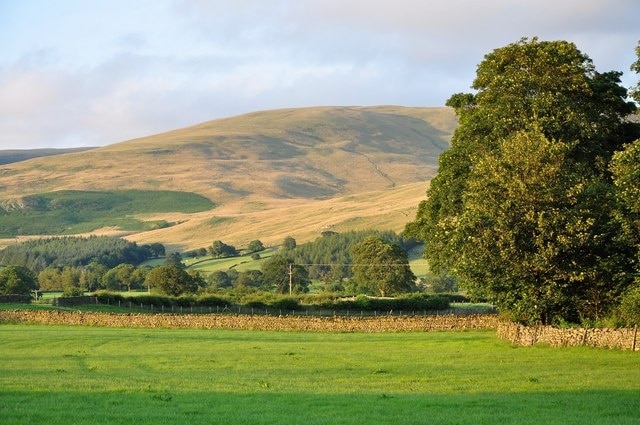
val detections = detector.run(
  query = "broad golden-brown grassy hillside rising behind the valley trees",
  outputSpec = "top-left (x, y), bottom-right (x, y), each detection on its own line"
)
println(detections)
top-left (0, 106), bottom-right (457, 248)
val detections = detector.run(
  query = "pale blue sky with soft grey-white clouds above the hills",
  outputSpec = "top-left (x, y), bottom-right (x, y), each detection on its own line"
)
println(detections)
top-left (0, 0), bottom-right (640, 149)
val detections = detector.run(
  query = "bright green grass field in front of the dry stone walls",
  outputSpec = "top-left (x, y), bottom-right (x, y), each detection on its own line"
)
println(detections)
top-left (0, 325), bottom-right (640, 425)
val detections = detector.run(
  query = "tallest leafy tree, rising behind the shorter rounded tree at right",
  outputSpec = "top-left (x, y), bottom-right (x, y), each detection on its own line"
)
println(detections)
top-left (406, 38), bottom-right (638, 272)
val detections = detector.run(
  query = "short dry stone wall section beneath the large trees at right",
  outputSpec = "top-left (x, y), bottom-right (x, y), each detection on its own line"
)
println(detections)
top-left (497, 321), bottom-right (640, 351)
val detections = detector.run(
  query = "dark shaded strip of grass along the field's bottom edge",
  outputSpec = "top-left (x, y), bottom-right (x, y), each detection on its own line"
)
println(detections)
top-left (0, 384), bottom-right (640, 425)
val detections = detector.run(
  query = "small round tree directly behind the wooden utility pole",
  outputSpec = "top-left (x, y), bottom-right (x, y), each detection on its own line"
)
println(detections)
top-left (262, 255), bottom-right (311, 294)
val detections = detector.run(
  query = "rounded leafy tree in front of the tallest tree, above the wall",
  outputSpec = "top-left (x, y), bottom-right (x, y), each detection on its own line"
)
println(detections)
top-left (453, 131), bottom-right (631, 323)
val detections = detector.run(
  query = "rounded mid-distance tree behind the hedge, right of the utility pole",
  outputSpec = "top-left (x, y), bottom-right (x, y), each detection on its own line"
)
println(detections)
top-left (351, 236), bottom-right (416, 297)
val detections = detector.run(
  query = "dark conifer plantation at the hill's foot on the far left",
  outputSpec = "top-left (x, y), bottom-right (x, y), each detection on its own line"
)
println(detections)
top-left (0, 236), bottom-right (152, 272)
